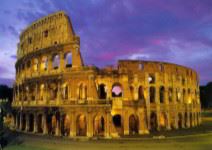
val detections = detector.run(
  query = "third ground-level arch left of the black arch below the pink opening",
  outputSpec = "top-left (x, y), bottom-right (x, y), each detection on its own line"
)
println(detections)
top-left (61, 114), bottom-right (71, 136)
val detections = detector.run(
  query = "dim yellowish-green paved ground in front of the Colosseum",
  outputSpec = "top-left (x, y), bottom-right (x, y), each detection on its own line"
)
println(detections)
top-left (2, 119), bottom-right (212, 150)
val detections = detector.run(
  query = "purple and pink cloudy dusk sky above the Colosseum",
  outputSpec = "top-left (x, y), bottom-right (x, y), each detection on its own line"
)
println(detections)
top-left (0, 0), bottom-right (212, 85)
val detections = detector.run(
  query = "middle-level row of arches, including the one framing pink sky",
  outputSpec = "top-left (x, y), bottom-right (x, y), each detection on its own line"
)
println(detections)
top-left (15, 81), bottom-right (198, 104)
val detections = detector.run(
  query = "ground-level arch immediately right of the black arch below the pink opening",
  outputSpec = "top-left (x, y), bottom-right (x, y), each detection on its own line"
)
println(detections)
top-left (129, 114), bottom-right (139, 135)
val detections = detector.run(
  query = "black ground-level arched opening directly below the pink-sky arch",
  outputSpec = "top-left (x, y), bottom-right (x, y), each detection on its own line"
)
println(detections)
top-left (113, 114), bottom-right (124, 135)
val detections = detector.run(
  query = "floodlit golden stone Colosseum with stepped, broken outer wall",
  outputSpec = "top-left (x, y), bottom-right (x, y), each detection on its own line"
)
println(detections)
top-left (12, 11), bottom-right (201, 138)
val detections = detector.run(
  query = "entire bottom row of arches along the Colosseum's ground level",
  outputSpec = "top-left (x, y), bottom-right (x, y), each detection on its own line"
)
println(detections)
top-left (15, 112), bottom-right (200, 136)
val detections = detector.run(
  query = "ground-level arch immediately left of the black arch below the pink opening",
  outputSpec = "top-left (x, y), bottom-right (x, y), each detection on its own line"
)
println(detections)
top-left (93, 116), bottom-right (105, 136)
